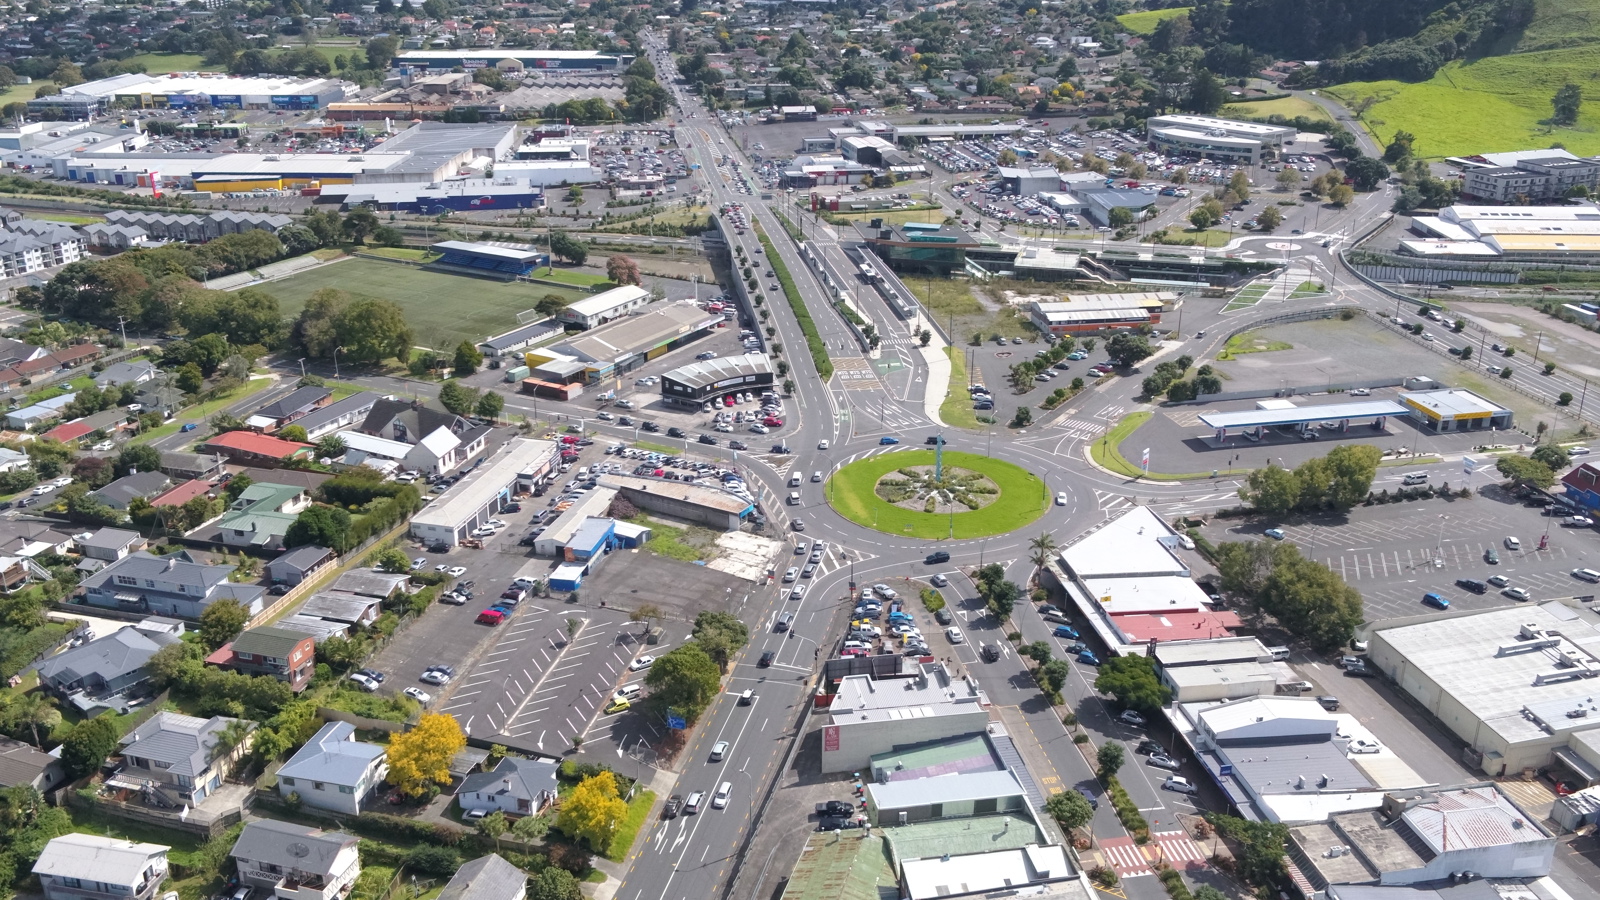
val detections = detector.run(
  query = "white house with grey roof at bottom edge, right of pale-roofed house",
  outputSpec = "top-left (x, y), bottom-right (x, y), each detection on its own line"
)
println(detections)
top-left (229, 818), bottom-right (362, 900)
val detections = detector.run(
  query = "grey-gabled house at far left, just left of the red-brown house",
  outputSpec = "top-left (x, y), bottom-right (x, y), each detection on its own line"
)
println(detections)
top-left (38, 625), bottom-right (179, 713)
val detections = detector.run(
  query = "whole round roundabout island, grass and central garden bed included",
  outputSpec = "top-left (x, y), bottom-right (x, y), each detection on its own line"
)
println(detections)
top-left (824, 450), bottom-right (1050, 540)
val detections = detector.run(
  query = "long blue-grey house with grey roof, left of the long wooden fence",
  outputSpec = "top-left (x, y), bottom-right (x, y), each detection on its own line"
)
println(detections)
top-left (83, 551), bottom-right (266, 620)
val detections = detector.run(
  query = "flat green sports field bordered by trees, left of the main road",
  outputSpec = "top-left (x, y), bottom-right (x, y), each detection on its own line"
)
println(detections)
top-left (259, 259), bottom-right (587, 348)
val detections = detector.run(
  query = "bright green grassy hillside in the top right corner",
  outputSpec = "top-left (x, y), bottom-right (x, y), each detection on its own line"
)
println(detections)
top-left (1326, 0), bottom-right (1600, 159)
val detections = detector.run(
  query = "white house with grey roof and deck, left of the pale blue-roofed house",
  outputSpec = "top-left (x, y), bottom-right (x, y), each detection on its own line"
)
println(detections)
top-left (106, 709), bottom-right (254, 809)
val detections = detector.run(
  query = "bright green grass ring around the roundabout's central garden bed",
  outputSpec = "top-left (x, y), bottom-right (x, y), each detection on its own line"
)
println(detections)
top-left (826, 450), bottom-right (1050, 540)
